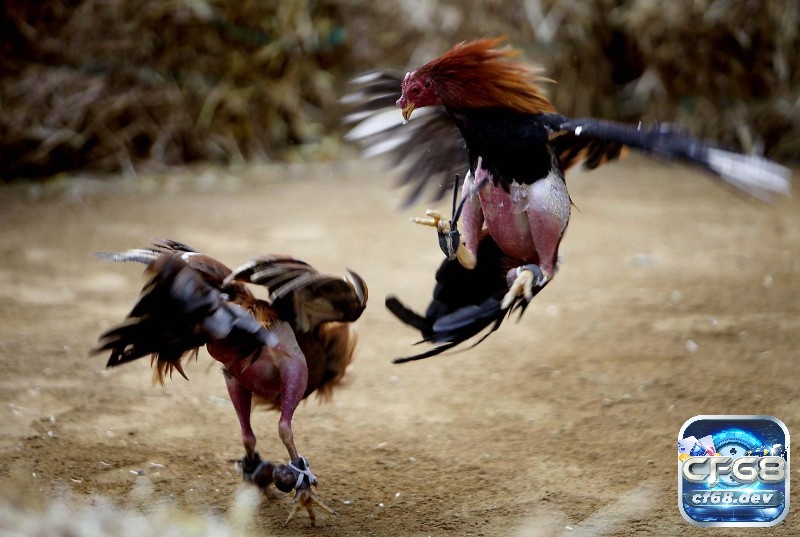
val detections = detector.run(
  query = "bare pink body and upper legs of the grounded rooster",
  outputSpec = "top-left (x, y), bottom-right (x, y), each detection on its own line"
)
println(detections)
top-left (207, 321), bottom-right (308, 460)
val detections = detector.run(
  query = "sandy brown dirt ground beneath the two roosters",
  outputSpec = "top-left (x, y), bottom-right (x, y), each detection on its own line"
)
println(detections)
top-left (0, 157), bottom-right (800, 536)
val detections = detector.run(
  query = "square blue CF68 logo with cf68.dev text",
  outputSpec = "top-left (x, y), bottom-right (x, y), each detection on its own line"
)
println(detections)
top-left (678, 416), bottom-right (790, 527)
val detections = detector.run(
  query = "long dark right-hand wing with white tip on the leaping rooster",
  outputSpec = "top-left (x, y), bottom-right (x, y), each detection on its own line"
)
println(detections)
top-left (542, 114), bottom-right (791, 200)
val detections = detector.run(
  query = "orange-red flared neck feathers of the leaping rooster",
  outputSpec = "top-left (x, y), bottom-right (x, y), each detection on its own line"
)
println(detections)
top-left (417, 37), bottom-right (555, 114)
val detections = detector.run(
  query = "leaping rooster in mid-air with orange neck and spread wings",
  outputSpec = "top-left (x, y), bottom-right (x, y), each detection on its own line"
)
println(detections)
top-left (347, 38), bottom-right (789, 361)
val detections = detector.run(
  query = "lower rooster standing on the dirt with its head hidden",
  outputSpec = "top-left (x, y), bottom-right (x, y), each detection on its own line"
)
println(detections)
top-left (95, 240), bottom-right (367, 524)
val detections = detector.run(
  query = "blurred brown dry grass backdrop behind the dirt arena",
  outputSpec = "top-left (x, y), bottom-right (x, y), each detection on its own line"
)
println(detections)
top-left (0, 0), bottom-right (800, 180)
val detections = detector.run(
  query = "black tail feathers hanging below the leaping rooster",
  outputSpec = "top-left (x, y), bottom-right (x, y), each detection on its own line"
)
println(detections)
top-left (386, 236), bottom-right (543, 363)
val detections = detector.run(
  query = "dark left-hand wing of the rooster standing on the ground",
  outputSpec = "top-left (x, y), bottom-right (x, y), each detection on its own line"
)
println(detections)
top-left (93, 244), bottom-right (274, 382)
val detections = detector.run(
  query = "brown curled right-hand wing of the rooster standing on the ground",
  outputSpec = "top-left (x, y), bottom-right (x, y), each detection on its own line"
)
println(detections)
top-left (226, 255), bottom-right (367, 332)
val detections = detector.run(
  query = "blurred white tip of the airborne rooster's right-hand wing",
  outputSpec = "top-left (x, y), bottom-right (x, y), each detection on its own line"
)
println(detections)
top-left (707, 148), bottom-right (791, 199)
